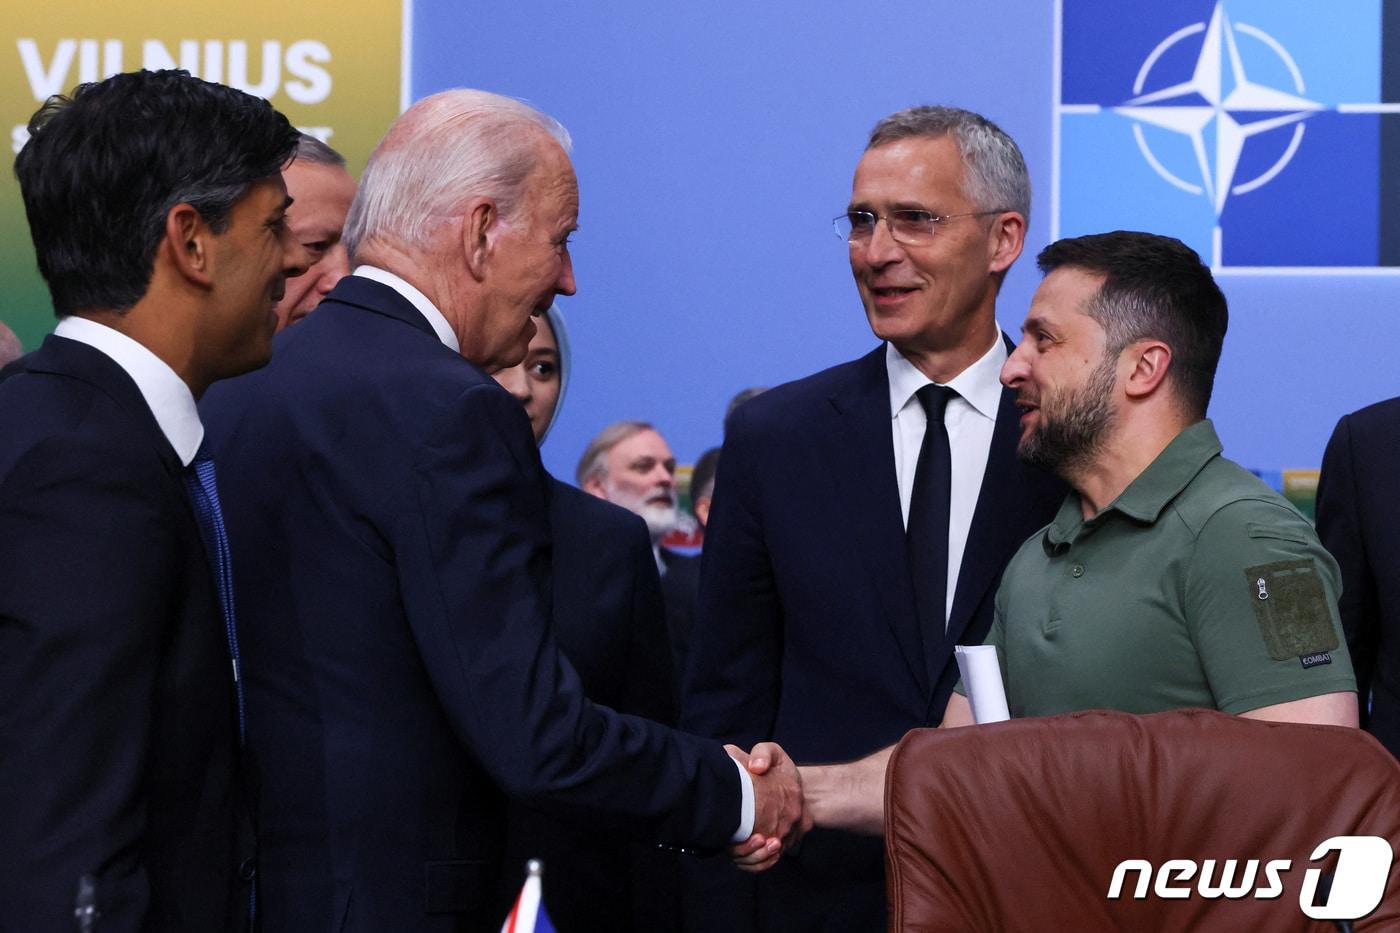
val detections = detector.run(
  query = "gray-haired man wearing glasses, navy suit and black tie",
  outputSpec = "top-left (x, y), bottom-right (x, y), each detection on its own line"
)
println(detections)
top-left (682, 108), bottom-right (1064, 932)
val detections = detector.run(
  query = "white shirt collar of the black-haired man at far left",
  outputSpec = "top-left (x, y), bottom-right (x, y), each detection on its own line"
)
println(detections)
top-left (53, 315), bottom-right (204, 467)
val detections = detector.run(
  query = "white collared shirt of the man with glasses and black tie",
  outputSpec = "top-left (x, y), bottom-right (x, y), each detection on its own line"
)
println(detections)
top-left (885, 332), bottom-right (1007, 618)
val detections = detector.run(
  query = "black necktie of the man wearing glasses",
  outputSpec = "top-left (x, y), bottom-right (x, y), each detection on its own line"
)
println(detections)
top-left (904, 384), bottom-right (958, 688)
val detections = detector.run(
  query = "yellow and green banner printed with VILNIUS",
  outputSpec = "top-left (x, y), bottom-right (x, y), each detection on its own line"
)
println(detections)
top-left (0, 0), bottom-right (406, 350)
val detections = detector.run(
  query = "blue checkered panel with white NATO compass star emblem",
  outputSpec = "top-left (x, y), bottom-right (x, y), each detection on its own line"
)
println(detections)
top-left (1051, 0), bottom-right (1400, 273)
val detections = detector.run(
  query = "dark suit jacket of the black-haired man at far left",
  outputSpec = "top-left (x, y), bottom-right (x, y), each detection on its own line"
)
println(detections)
top-left (0, 336), bottom-right (252, 933)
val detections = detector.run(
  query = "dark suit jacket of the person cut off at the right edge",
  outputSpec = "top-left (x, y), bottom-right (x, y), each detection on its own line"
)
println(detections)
top-left (1317, 398), bottom-right (1400, 758)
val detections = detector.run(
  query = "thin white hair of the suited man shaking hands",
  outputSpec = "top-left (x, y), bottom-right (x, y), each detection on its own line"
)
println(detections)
top-left (344, 88), bottom-right (570, 255)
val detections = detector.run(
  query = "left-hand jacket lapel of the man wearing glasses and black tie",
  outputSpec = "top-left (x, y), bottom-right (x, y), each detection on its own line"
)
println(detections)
top-left (826, 345), bottom-right (930, 693)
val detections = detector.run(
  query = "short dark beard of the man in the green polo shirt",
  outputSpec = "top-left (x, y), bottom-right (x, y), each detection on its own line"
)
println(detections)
top-left (1016, 353), bottom-right (1117, 479)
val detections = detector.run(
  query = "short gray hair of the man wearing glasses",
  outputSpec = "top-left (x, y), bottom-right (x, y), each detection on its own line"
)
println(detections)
top-left (865, 106), bottom-right (1030, 223)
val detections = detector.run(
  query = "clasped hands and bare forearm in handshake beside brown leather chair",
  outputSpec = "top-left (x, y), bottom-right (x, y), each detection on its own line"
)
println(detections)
top-left (724, 742), bottom-right (893, 871)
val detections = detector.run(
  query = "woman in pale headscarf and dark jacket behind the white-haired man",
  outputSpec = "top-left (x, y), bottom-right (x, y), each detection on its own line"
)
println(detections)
top-left (493, 305), bottom-right (679, 932)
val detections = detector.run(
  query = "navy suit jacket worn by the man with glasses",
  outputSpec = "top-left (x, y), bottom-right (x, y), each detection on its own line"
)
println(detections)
top-left (682, 346), bottom-right (1064, 929)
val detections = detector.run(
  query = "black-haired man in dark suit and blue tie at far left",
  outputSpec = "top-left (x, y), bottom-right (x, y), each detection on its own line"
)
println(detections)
top-left (0, 71), bottom-right (304, 933)
